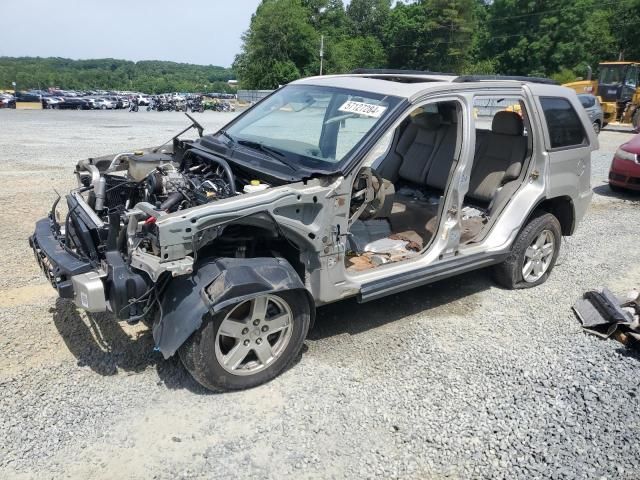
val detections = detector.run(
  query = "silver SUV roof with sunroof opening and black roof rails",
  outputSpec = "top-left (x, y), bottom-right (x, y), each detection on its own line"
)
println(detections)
top-left (290, 72), bottom-right (573, 100)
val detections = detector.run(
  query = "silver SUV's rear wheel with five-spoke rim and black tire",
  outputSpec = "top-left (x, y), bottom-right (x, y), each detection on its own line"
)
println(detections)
top-left (493, 211), bottom-right (562, 289)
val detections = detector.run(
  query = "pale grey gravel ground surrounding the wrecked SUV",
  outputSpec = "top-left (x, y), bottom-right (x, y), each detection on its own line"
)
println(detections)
top-left (0, 111), bottom-right (640, 479)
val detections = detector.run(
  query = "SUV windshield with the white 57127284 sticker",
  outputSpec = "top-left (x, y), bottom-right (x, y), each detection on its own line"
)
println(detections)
top-left (225, 85), bottom-right (400, 167)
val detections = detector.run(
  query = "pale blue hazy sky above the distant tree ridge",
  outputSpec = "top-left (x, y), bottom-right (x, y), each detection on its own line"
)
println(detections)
top-left (0, 0), bottom-right (260, 67)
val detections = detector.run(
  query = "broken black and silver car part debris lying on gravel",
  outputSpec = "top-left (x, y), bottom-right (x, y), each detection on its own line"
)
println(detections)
top-left (573, 288), bottom-right (640, 344)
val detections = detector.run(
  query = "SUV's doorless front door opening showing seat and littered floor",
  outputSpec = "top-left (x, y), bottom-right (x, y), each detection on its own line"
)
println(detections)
top-left (345, 101), bottom-right (462, 272)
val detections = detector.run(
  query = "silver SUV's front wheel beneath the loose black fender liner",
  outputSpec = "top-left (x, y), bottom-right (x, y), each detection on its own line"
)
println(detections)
top-left (178, 290), bottom-right (311, 390)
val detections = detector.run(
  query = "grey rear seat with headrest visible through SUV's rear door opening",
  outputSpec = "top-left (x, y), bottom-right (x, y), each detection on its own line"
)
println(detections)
top-left (467, 111), bottom-right (527, 204)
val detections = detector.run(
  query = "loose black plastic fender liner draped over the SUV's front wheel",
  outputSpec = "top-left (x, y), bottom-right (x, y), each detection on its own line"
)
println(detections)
top-left (153, 257), bottom-right (315, 358)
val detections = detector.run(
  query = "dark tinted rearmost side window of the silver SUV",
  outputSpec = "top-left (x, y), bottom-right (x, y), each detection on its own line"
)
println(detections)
top-left (540, 97), bottom-right (587, 148)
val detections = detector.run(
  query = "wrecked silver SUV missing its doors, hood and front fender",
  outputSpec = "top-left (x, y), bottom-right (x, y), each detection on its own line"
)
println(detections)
top-left (30, 71), bottom-right (598, 389)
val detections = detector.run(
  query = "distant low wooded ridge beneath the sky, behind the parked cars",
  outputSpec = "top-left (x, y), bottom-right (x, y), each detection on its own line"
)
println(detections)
top-left (0, 57), bottom-right (235, 93)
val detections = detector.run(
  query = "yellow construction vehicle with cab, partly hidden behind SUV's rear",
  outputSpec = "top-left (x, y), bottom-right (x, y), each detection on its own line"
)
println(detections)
top-left (564, 62), bottom-right (640, 129)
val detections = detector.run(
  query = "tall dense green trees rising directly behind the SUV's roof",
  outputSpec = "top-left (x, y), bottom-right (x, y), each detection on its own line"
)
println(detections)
top-left (233, 0), bottom-right (640, 89)
